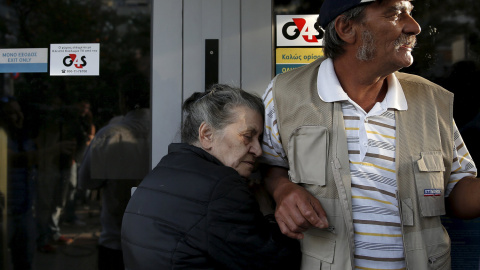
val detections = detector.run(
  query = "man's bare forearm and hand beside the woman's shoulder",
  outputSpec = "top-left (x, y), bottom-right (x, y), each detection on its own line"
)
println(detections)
top-left (263, 166), bottom-right (328, 239)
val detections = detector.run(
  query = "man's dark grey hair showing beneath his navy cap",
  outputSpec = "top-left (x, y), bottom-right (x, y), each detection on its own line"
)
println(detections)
top-left (323, 5), bottom-right (367, 59)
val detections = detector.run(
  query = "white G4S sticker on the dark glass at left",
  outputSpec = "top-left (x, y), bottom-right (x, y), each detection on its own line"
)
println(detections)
top-left (50, 43), bottom-right (100, 76)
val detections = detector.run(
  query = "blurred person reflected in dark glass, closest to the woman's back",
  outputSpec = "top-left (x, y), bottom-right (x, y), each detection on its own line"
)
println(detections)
top-left (79, 75), bottom-right (151, 270)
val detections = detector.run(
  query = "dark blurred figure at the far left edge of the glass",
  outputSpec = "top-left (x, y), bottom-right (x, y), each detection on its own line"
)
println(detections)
top-left (0, 96), bottom-right (38, 270)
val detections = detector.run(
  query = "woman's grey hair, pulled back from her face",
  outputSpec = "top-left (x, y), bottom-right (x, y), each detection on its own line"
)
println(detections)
top-left (181, 84), bottom-right (265, 144)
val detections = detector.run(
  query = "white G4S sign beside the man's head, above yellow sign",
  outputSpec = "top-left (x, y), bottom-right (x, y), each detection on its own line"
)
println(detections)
top-left (276, 14), bottom-right (323, 47)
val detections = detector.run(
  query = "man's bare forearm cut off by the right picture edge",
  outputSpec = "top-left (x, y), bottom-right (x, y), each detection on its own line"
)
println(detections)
top-left (447, 177), bottom-right (480, 219)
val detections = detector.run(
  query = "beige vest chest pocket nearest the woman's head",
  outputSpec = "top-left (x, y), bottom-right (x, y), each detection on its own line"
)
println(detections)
top-left (288, 126), bottom-right (328, 186)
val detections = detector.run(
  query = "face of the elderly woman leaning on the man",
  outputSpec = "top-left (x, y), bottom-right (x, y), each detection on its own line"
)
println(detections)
top-left (209, 106), bottom-right (263, 177)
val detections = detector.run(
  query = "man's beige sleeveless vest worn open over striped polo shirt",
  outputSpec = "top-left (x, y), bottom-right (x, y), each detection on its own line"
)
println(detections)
top-left (273, 59), bottom-right (454, 270)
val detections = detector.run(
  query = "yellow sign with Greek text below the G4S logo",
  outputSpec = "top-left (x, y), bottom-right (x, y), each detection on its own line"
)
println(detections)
top-left (275, 48), bottom-right (323, 74)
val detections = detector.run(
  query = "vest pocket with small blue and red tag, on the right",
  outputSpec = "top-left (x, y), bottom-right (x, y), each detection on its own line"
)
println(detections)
top-left (412, 151), bottom-right (445, 217)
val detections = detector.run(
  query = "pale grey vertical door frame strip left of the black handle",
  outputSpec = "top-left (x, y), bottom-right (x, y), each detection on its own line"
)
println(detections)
top-left (151, 0), bottom-right (183, 167)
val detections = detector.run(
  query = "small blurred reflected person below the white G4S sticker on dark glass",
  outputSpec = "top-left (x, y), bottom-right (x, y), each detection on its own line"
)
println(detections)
top-left (35, 96), bottom-right (82, 253)
